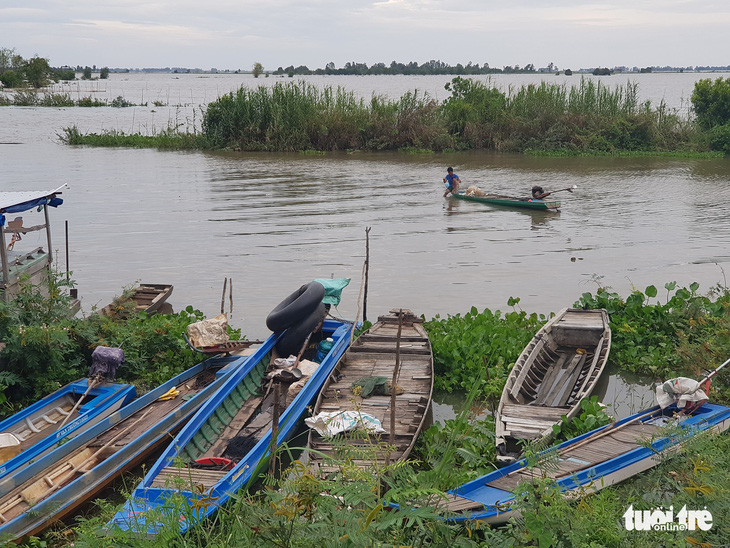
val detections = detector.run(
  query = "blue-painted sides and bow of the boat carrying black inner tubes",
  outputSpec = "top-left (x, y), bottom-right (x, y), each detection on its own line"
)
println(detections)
top-left (108, 320), bottom-right (353, 536)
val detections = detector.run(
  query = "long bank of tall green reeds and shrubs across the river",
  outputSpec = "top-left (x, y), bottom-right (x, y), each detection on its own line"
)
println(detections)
top-left (63, 77), bottom-right (727, 156)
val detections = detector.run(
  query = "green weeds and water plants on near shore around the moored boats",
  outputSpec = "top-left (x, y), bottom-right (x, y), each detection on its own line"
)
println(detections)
top-left (0, 275), bottom-right (730, 548)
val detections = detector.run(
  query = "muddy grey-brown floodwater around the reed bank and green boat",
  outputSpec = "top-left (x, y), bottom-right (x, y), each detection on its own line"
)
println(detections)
top-left (0, 70), bottom-right (730, 418)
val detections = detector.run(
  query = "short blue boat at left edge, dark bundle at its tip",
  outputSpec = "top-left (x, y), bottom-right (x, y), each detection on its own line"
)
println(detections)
top-left (0, 379), bottom-right (137, 482)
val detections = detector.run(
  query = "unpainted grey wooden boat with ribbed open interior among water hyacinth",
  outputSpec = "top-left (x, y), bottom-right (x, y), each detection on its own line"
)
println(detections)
top-left (495, 308), bottom-right (611, 462)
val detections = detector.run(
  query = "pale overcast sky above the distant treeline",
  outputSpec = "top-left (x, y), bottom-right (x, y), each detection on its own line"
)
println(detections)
top-left (0, 0), bottom-right (730, 70)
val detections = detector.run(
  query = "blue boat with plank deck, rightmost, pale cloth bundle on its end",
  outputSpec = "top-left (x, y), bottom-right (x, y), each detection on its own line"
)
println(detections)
top-left (440, 403), bottom-right (730, 523)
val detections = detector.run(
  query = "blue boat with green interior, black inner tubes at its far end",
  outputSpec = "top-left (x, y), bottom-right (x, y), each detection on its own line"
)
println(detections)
top-left (109, 320), bottom-right (353, 535)
